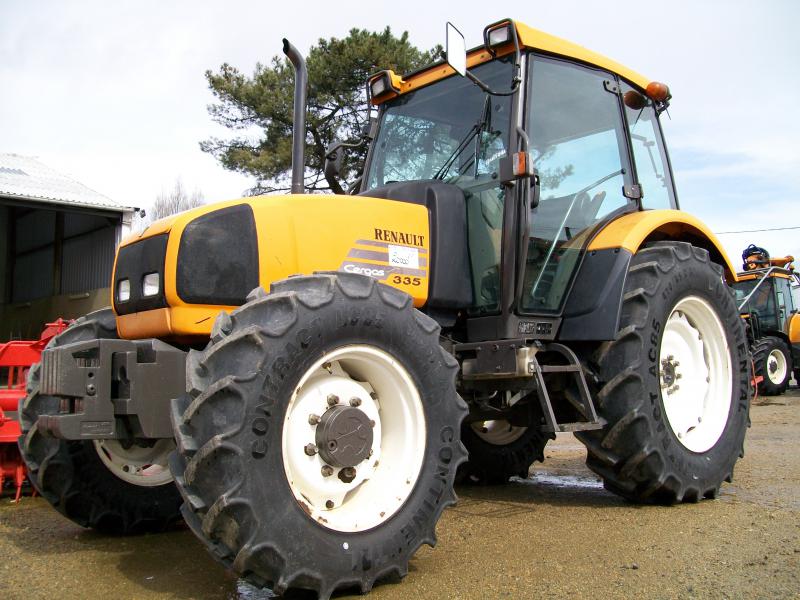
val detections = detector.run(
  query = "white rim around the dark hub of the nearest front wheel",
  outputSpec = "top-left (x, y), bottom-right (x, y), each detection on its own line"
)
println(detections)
top-left (282, 345), bottom-right (426, 532)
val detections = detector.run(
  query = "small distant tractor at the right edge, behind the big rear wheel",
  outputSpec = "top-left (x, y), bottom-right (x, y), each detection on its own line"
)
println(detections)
top-left (733, 244), bottom-right (800, 396)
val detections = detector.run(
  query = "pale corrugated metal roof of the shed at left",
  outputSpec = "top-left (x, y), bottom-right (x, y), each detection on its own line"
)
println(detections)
top-left (0, 153), bottom-right (134, 212)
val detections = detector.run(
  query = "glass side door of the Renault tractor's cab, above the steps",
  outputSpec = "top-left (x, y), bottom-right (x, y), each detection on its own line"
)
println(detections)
top-left (519, 54), bottom-right (638, 314)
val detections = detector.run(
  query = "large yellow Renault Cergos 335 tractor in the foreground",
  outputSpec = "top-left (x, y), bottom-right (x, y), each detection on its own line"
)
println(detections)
top-left (20, 19), bottom-right (750, 598)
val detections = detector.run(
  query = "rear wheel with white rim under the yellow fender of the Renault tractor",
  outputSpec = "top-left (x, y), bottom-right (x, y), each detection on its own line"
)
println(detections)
top-left (576, 242), bottom-right (750, 504)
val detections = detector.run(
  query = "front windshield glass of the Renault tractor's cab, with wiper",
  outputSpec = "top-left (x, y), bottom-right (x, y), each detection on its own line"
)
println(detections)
top-left (366, 56), bottom-right (513, 314)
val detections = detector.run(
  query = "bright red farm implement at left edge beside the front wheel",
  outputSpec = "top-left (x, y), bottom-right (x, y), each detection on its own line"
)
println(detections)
top-left (0, 319), bottom-right (69, 502)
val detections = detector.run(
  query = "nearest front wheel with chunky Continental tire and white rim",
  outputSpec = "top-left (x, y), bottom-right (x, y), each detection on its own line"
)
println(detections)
top-left (171, 273), bottom-right (467, 598)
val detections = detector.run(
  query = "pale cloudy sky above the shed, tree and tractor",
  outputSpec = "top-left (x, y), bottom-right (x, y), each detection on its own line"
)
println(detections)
top-left (0, 0), bottom-right (800, 266)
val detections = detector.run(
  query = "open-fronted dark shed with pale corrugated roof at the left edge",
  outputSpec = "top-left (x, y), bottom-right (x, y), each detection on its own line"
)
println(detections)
top-left (0, 153), bottom-right (135, 341)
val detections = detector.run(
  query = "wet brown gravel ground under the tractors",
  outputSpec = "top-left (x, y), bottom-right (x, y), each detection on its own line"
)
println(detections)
top-left (0, 389), bottom-right (800, 600)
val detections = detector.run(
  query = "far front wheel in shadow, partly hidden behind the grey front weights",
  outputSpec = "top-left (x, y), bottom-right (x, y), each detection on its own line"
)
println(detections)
top-left (19, 309), bottom-right (181, 534)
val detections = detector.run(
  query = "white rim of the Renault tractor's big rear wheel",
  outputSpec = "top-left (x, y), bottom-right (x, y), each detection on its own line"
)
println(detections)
top-left (659, 296), bottom-right (733, 452)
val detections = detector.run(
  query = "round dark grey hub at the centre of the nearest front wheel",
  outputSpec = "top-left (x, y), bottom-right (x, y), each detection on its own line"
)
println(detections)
top-left (316, 405), bottom-right (373, 467)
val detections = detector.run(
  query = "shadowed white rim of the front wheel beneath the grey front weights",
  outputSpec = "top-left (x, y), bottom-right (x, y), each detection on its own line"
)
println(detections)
top-left (94, 439), bottom-right (175, 487)
